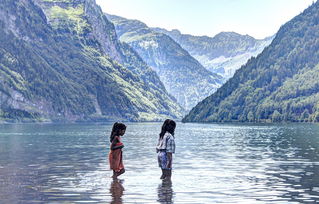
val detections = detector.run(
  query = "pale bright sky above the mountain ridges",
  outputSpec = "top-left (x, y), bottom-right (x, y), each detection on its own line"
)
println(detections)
top-left (96, 0), bottom-right (316, 39)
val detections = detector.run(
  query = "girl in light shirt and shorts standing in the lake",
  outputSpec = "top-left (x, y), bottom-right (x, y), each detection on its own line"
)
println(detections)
top-left (156, 119), bottom-right (176, 179)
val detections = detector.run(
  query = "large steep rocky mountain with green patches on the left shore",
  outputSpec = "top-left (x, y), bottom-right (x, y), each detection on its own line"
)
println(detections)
top-left (0, 0), bottom-right (183, 121)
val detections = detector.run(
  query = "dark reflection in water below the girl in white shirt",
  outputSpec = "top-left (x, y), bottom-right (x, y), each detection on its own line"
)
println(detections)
top-left (157, 180), bottom-right (174, 204)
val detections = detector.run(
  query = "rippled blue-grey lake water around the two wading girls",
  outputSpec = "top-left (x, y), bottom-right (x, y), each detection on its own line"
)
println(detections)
top-left (0, 123), bottom-right (319, 204)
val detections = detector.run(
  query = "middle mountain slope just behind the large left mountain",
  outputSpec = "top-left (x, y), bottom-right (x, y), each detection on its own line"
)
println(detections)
top-left (108, 15), bottom-right (223, 110)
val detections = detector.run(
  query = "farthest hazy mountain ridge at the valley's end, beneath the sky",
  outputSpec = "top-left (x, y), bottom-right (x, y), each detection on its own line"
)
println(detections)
top-left (153, 28), bottom-right (274, 80)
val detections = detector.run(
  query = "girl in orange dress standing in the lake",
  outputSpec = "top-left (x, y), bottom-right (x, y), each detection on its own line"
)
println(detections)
top-left (109, 122), bottom-right (126, 178)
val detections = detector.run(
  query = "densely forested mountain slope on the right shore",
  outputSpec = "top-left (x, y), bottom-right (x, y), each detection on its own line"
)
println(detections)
top-left (183, 1), bottom-right (319, 122)
